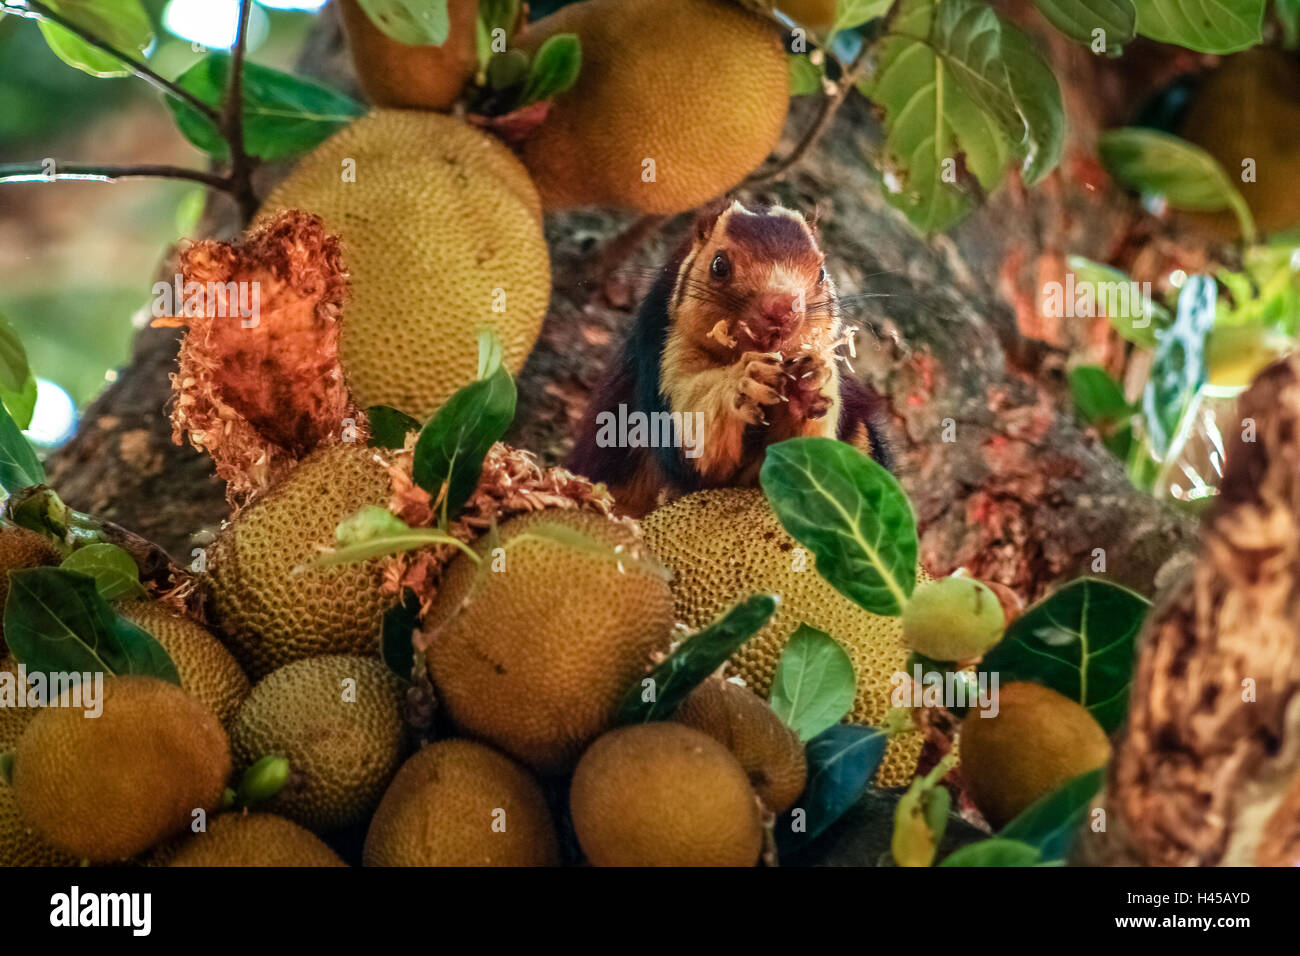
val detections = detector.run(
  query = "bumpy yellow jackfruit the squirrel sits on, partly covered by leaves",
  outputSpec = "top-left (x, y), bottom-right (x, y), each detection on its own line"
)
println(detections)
top-left (641, 488), bottom-right (927, 787)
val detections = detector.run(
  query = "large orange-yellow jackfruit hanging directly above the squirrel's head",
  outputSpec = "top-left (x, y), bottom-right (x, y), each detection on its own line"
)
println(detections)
top-left (519, 0), bottom-right (790, 215)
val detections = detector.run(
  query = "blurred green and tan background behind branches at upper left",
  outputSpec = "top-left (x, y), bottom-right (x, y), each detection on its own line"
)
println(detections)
top-left (0, 0), bottom-right (324, 446)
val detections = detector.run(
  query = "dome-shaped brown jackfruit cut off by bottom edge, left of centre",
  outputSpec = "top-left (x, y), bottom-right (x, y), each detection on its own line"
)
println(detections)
top-left (364, 740), bottom-right (560, 866)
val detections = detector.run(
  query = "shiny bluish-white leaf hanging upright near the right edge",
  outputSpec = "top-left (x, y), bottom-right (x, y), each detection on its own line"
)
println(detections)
top-left (1141, 276), bottom-right (1218, 460)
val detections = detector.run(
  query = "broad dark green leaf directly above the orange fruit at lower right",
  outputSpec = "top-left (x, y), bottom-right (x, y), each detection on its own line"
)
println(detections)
top-left (979, 578), bottom-right (1151, 734)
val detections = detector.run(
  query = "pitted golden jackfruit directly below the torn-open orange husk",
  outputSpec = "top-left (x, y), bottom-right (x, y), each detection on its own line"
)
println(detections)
top-left (208, 445), bottom-right (390, 680)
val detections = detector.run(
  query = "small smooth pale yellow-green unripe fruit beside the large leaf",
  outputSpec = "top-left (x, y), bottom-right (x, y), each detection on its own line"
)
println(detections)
top-left (902, 576), bottom-right (1006, 661)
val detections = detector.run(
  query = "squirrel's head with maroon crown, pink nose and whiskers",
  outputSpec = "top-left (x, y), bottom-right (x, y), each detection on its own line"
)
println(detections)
top-left (672, 202), bottom-right (839, 355)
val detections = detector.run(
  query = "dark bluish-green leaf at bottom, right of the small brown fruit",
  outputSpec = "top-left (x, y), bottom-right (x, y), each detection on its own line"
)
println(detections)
top-left (776, 723), bottom-right (889, 856)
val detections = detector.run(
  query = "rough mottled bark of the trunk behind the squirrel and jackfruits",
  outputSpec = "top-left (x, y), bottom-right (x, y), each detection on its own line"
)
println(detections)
top-left (51, 7), bottom-right (1206, 598)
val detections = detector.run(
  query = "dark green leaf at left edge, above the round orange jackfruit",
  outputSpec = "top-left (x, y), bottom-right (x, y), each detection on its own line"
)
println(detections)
top-left (4, 567), bottom-right (181, 684)
